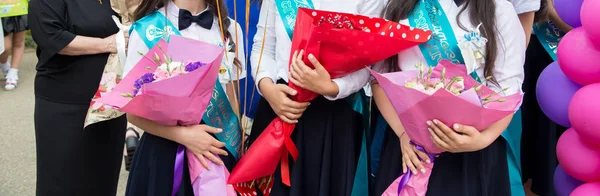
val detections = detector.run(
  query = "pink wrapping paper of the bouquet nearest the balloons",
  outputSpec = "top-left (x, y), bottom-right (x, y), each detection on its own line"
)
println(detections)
top-left (370, 61), bottom-right (523, 154)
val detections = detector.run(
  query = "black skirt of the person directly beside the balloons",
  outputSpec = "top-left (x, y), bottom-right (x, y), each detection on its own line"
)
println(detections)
top-left (521, 35), bottom-right (567, 196)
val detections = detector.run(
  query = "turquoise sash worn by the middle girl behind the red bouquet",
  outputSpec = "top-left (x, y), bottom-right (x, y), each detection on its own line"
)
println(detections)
top-left (275, 0), bottom-right (370, 196)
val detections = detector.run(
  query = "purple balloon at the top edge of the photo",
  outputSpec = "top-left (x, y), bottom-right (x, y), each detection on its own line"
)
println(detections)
top-left (554, 0), bottom-right (583, 28)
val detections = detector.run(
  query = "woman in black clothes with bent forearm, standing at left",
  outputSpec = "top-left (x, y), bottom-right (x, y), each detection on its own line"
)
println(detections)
top-left (29, 0), bottom-right (127, 196)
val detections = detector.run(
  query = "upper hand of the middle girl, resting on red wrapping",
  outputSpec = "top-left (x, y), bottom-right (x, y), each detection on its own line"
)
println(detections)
top-left (289, 50), bottom-right (339, 96)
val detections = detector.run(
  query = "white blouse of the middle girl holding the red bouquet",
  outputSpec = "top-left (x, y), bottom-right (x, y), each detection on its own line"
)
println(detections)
top-left (250, 0), bottom-right (384, 100)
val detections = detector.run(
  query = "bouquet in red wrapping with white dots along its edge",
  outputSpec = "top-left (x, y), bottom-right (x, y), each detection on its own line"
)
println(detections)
top-left (229, 8), bottom-right (431, 191)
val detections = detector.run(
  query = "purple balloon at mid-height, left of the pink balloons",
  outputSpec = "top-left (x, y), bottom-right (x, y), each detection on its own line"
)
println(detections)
top-left (536, 62), bottom-right (581, 127)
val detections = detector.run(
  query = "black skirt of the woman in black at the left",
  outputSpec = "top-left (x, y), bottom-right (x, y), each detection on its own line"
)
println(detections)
top-left (34, 97), bottom-right (127, 196)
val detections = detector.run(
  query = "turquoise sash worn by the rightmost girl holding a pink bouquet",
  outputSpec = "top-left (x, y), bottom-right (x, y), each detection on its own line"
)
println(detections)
top-left (408, 0), bottom-right (525, 196)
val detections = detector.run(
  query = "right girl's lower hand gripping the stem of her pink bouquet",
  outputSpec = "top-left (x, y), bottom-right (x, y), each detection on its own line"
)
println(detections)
top-left (400, 133), bottom-right (431, 175)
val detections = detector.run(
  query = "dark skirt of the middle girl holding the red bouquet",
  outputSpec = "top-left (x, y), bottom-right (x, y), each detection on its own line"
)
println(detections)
top-left (248, 80), bottom-right (363, 196)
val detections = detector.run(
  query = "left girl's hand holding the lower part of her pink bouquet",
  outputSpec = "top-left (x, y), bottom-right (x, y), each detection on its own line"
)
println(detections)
top-left (179, 125), bottom-right (227, 169)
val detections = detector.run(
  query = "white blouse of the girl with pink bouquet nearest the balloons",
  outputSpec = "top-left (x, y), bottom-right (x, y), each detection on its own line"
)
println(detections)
top-left (374, 0), bottom-right (527, 95)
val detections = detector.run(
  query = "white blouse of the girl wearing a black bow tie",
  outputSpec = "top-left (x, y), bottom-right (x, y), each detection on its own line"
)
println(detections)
top-left (123, 1), bottom-right (246, 89)
